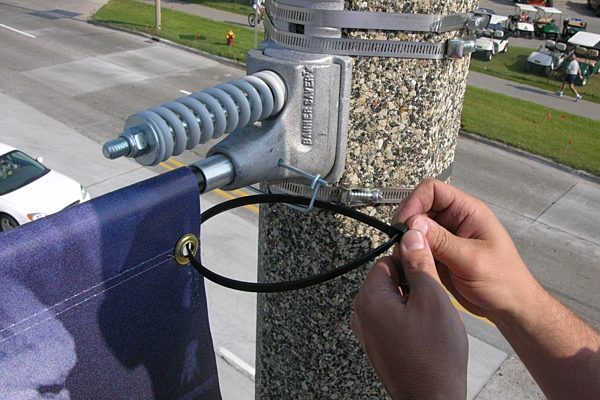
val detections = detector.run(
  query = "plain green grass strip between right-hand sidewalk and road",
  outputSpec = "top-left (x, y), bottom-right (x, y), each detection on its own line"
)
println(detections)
top-left (462, 86), bottom-right (600, 176)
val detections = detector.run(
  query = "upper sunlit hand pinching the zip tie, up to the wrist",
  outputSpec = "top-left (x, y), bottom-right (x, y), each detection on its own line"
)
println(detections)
top-left (394, 179), bottom-right (542, 321)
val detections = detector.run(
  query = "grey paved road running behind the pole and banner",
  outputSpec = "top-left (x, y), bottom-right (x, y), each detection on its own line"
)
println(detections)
top-left (0, 0), bottom-right (600, 399)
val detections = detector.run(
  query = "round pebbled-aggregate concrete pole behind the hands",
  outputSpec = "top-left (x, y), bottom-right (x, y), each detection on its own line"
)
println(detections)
top-left (256, 0), bottom-right (477, 400)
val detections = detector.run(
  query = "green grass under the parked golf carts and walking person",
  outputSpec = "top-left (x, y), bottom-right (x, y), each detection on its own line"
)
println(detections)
top-left (470, 46), bottom-right (600, 103)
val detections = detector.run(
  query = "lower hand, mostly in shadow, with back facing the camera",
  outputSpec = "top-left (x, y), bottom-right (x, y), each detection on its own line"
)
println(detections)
top-left (352, 230), bottom-right (468, 400)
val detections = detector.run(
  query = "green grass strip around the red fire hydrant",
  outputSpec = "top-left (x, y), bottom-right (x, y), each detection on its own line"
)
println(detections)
top-left (92, 0), bottom-right (263, 62)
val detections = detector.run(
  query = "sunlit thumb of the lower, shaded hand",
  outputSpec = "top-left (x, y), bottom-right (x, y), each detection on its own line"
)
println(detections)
top-left (400, 230), bottom-right (442, 293)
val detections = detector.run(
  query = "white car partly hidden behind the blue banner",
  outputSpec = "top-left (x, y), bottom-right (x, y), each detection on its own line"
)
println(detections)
top-left (0, 143), bottom-right (90, 232)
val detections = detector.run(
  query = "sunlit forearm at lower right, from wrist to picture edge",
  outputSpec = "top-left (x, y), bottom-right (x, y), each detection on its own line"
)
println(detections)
top-left (493, 286), bottom-right (600, 399)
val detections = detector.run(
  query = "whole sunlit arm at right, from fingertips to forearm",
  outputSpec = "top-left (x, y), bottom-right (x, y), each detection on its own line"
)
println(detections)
top-left (394, 181), bottom-right (600, 399)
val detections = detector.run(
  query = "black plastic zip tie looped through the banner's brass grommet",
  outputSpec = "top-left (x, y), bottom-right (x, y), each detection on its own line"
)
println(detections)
top-left (187, 194), bottom-right (408, 293)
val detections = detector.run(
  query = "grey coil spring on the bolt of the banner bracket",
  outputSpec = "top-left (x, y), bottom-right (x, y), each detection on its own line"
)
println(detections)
top-left (125, 70), bottom-right (286, 164)
